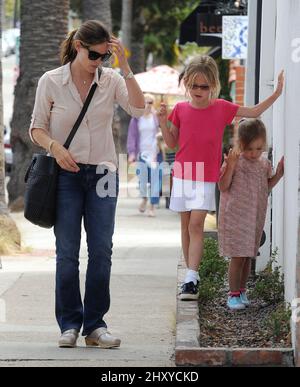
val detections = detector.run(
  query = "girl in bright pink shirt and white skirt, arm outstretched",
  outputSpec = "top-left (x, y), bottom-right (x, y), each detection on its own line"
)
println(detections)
top-left (159, 55), bottom-right (284, 300)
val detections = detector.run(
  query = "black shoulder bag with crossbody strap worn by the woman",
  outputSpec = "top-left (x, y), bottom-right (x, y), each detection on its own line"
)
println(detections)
top-left (24, 71), bottom-right (101, 228)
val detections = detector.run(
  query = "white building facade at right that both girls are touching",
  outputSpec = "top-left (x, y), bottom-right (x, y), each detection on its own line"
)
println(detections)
top-left (246, 0), bottom-right (300, 365)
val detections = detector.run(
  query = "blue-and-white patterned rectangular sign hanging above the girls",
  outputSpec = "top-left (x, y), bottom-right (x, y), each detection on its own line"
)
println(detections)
top-left (222, 16), bottom-right (248, 59)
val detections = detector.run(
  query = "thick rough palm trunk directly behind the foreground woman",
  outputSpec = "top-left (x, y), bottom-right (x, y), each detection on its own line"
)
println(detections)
top-left (8, 0), bottom-right (69, 208)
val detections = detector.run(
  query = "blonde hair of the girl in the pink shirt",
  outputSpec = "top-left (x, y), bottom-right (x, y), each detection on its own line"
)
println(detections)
top-left (181, 55), bottom-right (221, 99)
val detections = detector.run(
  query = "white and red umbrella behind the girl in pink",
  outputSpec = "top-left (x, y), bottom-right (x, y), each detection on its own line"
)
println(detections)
top-left (135, 65), bottom-right (185, 95)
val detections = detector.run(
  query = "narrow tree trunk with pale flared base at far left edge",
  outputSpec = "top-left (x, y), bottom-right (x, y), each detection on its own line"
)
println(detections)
top-left (0, 0), bottom-right (21, 254)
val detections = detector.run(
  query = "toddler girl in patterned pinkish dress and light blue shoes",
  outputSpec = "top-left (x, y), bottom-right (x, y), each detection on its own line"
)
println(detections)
top-left (219, 119), bottom-right (283, 310)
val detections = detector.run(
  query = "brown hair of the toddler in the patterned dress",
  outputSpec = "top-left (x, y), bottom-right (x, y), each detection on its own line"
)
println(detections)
top-left (236, 118), bottom-right (267, 152)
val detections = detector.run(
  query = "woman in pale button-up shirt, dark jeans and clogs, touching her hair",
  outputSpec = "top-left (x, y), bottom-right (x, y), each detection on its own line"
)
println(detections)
top-left (30, 20), bottom-right (144, 348)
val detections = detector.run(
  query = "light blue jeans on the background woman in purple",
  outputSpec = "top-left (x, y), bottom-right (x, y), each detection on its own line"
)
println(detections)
top-left (137, 153), bottom-right (163, 205)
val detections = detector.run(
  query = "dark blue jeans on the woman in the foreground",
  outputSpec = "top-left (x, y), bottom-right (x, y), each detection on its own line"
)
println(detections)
top-left (54, 164), bottom-right (119, 336)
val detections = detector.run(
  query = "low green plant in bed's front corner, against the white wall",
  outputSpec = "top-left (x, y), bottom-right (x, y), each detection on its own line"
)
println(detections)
top-left (265, 302), bottom-right (292, 340)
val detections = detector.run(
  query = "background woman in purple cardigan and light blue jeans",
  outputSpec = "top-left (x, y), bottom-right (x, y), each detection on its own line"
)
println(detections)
top-left (127, 94), bottom-right (163, 217)
